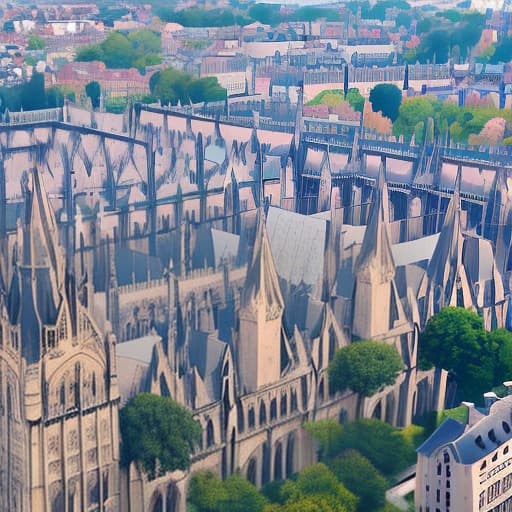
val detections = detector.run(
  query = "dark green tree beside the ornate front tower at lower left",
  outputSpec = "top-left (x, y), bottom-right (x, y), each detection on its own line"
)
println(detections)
top-left (119, 393), bottom-right (202, 479)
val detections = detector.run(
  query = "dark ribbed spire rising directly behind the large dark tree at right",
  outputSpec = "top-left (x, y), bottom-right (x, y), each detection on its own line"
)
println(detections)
top-left (420, 166), bottom-right (473, 324)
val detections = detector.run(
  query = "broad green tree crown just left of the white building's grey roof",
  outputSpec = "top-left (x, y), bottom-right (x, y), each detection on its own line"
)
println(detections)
top-left (340, 419), bottom-right (416, 477)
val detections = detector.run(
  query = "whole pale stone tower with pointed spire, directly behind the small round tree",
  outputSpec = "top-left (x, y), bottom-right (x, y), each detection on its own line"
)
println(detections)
top-left (352, 163), bottom-right (406, 339)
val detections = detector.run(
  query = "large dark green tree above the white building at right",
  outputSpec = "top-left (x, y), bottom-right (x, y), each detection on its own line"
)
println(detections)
top-left (419, 307), bottom-right (495, 401)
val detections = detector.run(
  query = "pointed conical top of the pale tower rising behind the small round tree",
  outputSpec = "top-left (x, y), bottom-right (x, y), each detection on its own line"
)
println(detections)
top-left (356, 162), bottom-right (395, 281)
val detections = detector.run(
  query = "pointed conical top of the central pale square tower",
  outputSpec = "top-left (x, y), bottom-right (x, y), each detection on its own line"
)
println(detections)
top-left (242, 207), bottom-right (284, 317)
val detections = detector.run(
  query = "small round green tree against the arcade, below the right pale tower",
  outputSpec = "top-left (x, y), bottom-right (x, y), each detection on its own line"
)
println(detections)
top-left (329, 340), bottom-right (404, 396)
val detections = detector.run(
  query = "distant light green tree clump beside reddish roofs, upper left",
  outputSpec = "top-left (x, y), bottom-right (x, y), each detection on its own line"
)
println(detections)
top-left (75, 29), bottom-right (162, 71)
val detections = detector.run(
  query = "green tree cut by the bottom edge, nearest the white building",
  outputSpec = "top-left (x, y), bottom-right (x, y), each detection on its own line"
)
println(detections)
top-left (329, 450), bottom-right (388, 512)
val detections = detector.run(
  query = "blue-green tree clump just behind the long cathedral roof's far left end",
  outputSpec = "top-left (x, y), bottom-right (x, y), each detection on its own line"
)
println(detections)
top-left (149, 68), bottom-right (226, 105)
